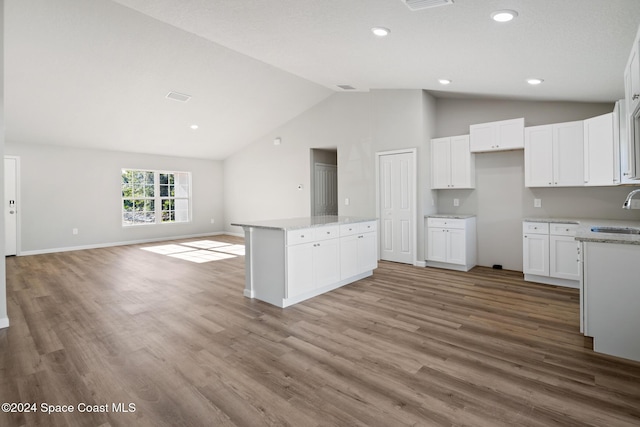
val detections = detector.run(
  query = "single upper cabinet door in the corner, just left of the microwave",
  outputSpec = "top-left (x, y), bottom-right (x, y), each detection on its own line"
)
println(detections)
top-left (584, 113), bottom-right (615, 186)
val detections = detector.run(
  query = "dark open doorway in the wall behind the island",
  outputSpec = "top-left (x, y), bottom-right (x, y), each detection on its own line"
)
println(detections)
top-left (311, 148), bottom-right (338, 216)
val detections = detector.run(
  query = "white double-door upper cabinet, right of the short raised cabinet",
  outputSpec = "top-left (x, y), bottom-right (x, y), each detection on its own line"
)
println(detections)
top-left (524, 121), bottom-right (584, 187)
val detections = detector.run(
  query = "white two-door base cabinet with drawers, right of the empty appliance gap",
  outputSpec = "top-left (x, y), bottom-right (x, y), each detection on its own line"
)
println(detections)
top-left (522, 221), bottom-right (580, 288)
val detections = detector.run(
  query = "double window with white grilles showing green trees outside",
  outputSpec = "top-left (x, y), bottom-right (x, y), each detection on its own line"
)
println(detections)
top-left (122, 169), bottom-right (191, 226)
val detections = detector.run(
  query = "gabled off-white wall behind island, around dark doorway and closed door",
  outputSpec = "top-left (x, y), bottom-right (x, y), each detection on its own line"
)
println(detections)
top-left (224, 90), bottom-right (435, 259)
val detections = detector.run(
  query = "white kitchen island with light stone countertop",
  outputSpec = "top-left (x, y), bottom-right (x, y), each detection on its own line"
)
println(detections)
top-left (231, 216), bottom-right (378, 307)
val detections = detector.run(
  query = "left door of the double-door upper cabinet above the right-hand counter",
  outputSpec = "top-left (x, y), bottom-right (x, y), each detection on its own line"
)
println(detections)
top-left (524, 125), bottom-right (553, 187)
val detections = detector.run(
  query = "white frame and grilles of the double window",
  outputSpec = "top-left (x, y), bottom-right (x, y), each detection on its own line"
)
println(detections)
top-left (120, 168), bottom-right (192, 228)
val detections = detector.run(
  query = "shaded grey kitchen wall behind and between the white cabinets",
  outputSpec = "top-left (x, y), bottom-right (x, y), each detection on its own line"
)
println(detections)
top-left (436, 99), bottom-right (640, 271)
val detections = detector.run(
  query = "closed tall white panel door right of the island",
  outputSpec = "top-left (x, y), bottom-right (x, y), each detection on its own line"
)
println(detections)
top-left (378, 152), bottom-right (416, 264)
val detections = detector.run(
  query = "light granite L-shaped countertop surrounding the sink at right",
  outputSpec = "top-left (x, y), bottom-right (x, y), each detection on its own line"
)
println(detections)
top-left (523, 218), bottom-right (640, 245)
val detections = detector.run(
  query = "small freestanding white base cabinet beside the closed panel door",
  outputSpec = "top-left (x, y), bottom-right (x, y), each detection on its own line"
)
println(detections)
top-left (427, 217), bottom-right (476, 271)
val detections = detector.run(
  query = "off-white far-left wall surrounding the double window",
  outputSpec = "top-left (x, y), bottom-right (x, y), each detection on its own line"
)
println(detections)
top-left (5, 142), bottom-right (224, 254)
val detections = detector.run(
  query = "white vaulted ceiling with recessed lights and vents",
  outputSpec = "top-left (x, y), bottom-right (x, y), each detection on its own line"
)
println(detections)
top-left (5, 0), bottom-right (640, 159)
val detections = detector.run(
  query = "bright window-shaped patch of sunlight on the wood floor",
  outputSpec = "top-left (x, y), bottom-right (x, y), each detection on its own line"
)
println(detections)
top-left (141, 240), bottom-right (244, 263)
